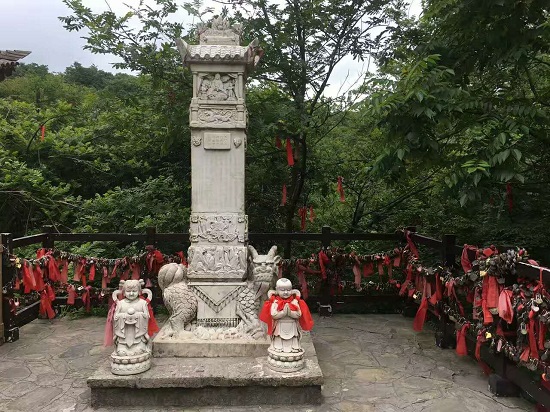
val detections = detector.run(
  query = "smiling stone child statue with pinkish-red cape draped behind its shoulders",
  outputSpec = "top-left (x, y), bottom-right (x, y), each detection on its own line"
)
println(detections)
top-left (105, 279), bottom-right (158, 375)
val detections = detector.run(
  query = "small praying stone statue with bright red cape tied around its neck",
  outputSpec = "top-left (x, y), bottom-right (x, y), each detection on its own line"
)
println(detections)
top-left (260, 278), bottom-right (313, 372)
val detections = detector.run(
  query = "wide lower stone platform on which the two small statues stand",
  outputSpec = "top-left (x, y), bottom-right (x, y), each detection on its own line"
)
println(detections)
top-left (88, 334), bottom-right (323, 408)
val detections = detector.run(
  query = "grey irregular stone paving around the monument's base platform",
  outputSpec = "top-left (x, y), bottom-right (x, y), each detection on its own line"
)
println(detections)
top-left (0, 315), bottom-right (534, 412)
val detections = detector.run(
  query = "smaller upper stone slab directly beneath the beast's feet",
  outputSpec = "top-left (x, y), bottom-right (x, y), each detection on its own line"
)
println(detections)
top-left (153, 334), bottom-right (269, 358)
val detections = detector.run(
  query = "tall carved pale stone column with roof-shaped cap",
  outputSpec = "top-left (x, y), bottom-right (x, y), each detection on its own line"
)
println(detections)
top-left (177, 19), bottom-right (261, 327)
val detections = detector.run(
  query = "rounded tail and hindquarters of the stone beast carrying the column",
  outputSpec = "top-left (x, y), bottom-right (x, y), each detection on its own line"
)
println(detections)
top-left (158, 263), bottom-right (197, 337)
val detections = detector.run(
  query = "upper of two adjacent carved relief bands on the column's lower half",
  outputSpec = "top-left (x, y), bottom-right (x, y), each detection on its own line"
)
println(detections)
top-left (189, 213), bottom-right (248, 243)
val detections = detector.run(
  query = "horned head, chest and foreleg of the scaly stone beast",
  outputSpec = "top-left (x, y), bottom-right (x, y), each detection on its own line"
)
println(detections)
top-left (237, 246), bottom-right (281, 339)
